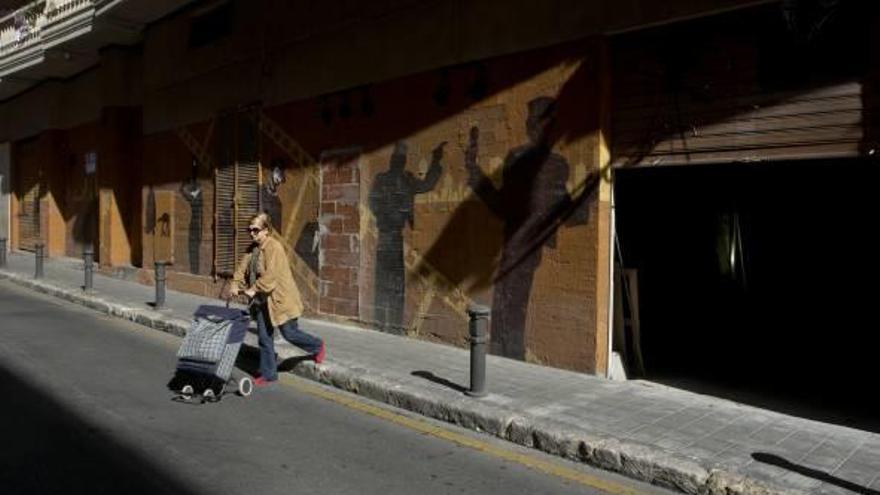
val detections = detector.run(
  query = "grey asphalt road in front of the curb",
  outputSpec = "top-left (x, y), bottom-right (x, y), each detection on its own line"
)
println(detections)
top-left (0, 282), bottom-right (668, 495)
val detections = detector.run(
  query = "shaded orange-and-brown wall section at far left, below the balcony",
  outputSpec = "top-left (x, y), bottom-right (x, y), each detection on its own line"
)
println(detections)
top-left (12, 114), bottom-right (141, 266)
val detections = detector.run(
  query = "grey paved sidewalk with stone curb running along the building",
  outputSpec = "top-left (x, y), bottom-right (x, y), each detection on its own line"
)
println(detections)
top-left (0, 253), bottom-right (880, 494)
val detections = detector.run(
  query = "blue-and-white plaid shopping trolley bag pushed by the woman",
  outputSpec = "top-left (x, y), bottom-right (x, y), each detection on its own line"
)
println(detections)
top-left (171, 305), bottom-right (253, 401)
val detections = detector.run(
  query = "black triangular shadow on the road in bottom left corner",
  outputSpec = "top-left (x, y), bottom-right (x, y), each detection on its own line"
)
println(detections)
top-left (0, 366), bottom-right (202, 495)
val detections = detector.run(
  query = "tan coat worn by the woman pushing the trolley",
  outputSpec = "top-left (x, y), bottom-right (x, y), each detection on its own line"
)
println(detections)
top-left (233, 235), bottom-right (303, 327)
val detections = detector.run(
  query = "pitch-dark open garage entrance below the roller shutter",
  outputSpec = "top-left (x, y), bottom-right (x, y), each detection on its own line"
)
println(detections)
top-left (615, 159), bottom-right (880, 431)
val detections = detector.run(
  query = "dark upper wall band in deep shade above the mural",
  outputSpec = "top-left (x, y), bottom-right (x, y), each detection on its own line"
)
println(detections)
top-left (136, 0), bottom-right (771, 132)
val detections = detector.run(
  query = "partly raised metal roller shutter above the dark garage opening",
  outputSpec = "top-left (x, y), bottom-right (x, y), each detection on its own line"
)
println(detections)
top-left (612, 5), bottom-right (864, 167)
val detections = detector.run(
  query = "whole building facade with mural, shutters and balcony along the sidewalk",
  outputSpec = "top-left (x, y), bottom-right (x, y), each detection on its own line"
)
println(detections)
top-left (0, 0), bottom-right (877, 406)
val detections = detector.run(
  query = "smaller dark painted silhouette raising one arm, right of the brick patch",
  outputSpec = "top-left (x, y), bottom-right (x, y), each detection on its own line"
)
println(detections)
top-left (370, 141), bottom-right (446, 333)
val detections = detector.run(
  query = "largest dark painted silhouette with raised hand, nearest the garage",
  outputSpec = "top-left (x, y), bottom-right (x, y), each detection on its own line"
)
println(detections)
top-left (465, 97), bottom-right (586, 359)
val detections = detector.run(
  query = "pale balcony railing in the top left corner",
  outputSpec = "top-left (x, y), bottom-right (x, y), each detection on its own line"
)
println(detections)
top-left (0, 0), bottom-right (100, 57)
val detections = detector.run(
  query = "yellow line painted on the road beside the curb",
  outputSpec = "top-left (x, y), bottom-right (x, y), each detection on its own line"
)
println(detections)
top-left (279, 375), bottom-right (647, 495)
